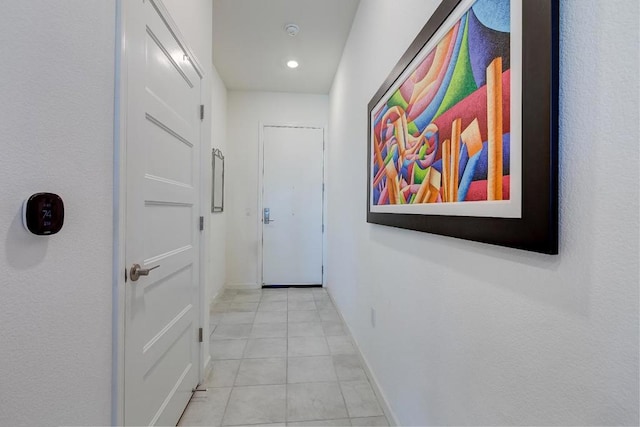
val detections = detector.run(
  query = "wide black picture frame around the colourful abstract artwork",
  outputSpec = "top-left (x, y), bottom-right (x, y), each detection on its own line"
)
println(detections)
top-left (366, 0), bottom-right (559, 255)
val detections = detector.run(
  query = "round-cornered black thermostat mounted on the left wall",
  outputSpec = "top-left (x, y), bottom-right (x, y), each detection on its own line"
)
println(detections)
top-left (22, 193), bottom-right (64, 236)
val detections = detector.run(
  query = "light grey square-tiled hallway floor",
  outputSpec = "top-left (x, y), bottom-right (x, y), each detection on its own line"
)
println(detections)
top-left (179, 288), bottom-right (389, 426)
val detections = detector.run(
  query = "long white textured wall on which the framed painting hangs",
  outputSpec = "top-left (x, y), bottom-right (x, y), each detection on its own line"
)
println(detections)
top-left (327, 0), bottom-right (640, 425)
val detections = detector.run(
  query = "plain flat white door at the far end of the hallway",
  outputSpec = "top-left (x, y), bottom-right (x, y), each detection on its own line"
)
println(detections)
top-left (262, 126), bottom-right (324, 285)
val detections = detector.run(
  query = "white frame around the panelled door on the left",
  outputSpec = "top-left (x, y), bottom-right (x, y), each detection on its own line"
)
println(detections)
top-left (111, 0), bottom-right (211, 425)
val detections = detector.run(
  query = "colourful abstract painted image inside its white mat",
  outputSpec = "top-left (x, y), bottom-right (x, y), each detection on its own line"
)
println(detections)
top-left (371, 0), bottom-right (511, 211)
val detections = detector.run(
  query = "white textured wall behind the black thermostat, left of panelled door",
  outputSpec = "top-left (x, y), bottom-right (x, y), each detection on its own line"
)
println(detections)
top-left (0, 0), bottom-right (116, 426)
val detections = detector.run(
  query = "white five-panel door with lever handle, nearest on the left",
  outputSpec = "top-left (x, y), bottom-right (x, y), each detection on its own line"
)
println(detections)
top-left (123, 0), bottom-right (201, 426)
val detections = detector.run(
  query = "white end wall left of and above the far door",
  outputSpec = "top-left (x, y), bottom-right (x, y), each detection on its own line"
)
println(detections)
top-left (225, 91), bottom-right (329, 287)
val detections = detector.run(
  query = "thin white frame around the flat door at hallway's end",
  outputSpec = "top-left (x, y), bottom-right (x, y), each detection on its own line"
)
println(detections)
top-left (256, 122), bottom-right (327, 288)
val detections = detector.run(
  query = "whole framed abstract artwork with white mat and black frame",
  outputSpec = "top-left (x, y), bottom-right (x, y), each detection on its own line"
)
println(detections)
top-left (367, 0), bottom-right (559, 254)
